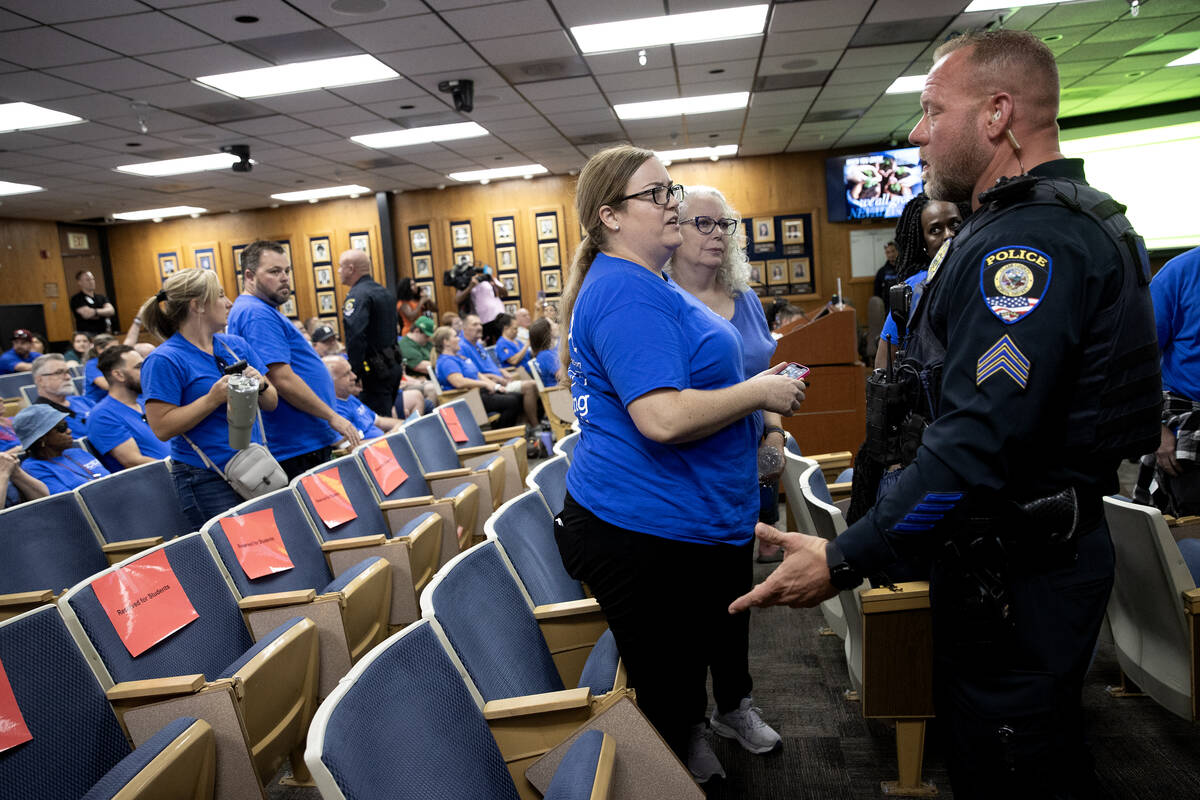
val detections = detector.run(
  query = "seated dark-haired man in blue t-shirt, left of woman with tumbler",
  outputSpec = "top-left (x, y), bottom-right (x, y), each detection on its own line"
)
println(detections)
top-left (88, 344), bottom-right (170, 473)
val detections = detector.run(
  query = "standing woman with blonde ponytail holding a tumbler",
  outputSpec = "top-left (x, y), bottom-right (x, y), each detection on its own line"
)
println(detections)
top-left (138, 270), bottom-right (278, 530)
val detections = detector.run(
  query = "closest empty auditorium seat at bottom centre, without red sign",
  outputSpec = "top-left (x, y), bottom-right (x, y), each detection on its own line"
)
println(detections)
top-left (305, 620), bottom-right (616, 800)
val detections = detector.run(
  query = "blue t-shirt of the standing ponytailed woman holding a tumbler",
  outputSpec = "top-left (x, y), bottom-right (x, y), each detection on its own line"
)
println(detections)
top-left (142, 333), bottom-right (266, 469)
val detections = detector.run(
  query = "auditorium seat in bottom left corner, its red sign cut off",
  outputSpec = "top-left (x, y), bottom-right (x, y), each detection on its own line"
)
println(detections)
top-left (0, 606), bottom-right (216, 800)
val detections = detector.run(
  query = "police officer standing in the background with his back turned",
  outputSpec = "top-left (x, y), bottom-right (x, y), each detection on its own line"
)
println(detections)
top-left (337, 249), bottom-right (402, 416)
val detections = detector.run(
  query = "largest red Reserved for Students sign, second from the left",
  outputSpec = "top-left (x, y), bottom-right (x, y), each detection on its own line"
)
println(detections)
top-left (91, 551), bottom-right (199, 658)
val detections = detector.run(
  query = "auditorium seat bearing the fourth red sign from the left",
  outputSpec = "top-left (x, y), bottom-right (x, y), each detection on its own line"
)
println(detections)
top-left (292, 456), bottom-right (446, 628)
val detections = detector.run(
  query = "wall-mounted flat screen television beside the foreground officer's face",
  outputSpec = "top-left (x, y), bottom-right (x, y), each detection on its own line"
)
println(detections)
top-left (826, 148), bottom-right (923, 222)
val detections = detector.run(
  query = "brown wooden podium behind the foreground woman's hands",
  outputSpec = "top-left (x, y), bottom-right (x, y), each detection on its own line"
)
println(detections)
top-left (773, 307), bottom-right (866, 455)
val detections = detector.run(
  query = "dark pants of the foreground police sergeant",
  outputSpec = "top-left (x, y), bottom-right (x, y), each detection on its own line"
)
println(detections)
top-left (931, 519), bottom-right (1114, 800)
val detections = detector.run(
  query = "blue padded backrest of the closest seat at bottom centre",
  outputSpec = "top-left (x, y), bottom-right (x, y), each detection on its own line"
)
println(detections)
top-left (320, 622), bottom-right (518, 800)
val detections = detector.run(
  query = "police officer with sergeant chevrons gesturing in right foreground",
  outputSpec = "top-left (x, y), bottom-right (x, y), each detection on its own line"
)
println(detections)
top-left (731, 30), bottom-right (1159, 798)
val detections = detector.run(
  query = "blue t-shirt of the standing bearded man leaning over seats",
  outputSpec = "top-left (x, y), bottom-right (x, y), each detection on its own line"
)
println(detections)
top-left (226, 294), bottom-right (342, 461)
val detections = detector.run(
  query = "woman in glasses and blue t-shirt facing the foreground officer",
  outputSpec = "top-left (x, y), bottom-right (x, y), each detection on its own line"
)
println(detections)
top-left (556, 146), bottom-right (804, 782)
